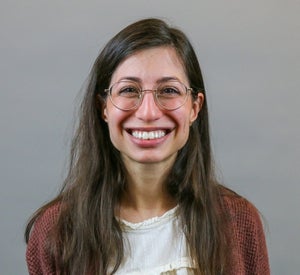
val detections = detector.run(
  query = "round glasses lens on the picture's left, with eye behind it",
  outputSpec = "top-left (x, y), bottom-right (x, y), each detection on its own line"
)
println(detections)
top-left (110, 81), bottom-right (141, 110)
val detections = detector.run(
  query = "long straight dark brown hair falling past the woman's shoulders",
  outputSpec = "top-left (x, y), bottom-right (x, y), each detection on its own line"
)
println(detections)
top-left (25, 18), bottom-right (226, 274)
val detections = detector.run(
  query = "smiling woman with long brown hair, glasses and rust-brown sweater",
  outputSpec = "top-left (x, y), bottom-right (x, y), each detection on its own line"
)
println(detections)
top-left (25, 19), bottom-right (269, 274)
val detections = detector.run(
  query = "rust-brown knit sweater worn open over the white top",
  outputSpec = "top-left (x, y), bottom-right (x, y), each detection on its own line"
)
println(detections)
top-left (26, 194), bottom-right (270, 275)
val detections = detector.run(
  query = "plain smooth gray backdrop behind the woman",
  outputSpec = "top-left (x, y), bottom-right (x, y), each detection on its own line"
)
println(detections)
top-left (0, 0), bottom-right (300, 275)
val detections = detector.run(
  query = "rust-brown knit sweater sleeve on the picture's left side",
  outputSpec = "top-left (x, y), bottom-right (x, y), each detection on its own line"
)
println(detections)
top-left (26, 205), bottom-right (59, 275)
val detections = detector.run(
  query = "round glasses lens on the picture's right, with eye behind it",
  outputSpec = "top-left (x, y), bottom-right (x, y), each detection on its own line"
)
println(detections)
top-left (156, 81), bottom-right (187, 110)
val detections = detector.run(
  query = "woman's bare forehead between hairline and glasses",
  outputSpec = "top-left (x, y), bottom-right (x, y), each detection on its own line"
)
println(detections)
top-left (111, 47), bottom-right (188, 84)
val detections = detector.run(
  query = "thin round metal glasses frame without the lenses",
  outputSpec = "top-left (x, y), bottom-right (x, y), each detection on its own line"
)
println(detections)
top-left (104, 80), bottom-right (193, 111)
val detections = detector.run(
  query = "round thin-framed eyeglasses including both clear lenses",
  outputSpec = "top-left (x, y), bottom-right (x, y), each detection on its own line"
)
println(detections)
top-left (104, 80), bottom-right (193, 111)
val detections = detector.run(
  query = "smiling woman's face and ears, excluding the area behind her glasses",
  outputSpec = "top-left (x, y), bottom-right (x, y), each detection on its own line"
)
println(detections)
top-left (103, 47), bottom-right (203, 167)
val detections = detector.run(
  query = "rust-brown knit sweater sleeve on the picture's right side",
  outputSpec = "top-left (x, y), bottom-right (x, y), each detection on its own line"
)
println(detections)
top-left (225, 197), bottom-right (270, 275)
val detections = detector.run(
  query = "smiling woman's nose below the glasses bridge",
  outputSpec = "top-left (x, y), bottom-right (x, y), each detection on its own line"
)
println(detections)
top-left (135, 90), bottom-right (162, 121)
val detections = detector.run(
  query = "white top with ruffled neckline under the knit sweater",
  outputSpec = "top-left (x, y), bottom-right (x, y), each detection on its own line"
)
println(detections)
top-left (112, 207), bottom-right (194, 275)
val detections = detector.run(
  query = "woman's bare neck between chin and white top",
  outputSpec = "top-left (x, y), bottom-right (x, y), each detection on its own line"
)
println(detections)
top-left (119, 157), bottom-right (176, 222)
